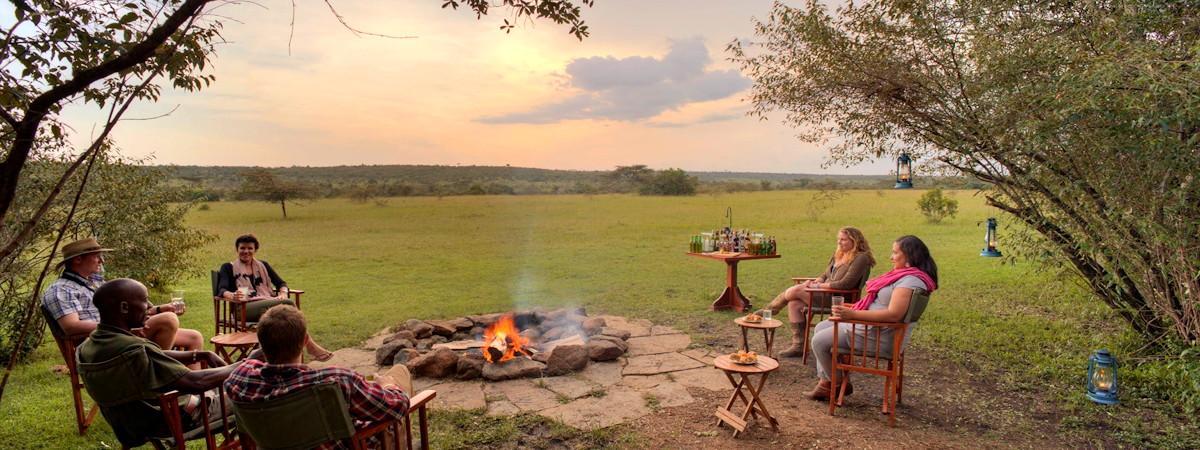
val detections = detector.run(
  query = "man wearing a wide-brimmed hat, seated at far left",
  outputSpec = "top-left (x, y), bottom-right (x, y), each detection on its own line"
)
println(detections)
top-left (42, 238), bottom-right (204, 357)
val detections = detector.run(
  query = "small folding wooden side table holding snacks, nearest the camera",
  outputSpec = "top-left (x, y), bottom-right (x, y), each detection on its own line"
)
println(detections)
top-left (713, 355), bottom-right (779, 438)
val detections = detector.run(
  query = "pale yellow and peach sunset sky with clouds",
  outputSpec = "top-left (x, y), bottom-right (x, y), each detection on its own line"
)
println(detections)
top-left (68, 0), bottom-right (892, 174)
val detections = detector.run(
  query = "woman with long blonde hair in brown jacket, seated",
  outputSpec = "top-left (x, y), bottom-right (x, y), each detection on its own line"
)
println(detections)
top-left (769, 227), bottom-right (875, 358)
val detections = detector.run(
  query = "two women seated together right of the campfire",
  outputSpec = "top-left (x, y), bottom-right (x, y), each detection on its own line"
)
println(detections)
top-left (768, 227), bottom-right (937, 401)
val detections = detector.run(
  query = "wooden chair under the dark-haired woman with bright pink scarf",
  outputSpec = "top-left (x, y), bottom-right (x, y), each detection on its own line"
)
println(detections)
top-left (829, 289), bottom-right (929, 426)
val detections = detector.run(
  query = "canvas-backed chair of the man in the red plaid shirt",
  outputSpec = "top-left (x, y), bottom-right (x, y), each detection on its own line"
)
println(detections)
top-left (233, 382), bottom-right (437, 450)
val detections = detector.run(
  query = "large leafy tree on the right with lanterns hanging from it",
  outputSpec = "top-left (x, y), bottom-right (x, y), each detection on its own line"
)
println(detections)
top-left (730, 0), bottom-right (1200, 343)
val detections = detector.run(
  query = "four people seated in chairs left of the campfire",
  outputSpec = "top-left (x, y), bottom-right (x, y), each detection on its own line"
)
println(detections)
top-left (42, 234), bottom-right (412, 446)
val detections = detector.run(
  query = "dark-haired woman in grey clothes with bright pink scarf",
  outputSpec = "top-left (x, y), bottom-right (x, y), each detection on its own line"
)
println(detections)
top-left (809, 235), bottom-right (937, 401)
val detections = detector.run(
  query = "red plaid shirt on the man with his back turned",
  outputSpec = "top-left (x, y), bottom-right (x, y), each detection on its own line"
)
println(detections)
top-left (224, 359), bottom-right (408, 449)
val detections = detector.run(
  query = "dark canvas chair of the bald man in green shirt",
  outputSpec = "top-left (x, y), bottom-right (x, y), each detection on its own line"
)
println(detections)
top-left (76, 348), bottom-right (240, 450)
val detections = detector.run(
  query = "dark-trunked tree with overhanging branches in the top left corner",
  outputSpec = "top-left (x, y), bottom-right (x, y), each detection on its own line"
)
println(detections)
top-left (0, 0), bottom-right (593, 405)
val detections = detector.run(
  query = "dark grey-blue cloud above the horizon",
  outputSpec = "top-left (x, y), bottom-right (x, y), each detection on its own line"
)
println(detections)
top-left (478, 38), bottom-right (750, 124)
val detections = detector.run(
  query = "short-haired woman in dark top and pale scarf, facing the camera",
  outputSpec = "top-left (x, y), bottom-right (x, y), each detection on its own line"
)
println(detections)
top-left (217, 234), bottom-right (334, 361)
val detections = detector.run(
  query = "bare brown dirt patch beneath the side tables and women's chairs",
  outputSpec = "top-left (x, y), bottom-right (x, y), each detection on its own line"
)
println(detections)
top-left (630, 324), bottom-right (1080, 450)
